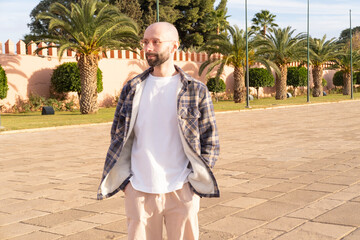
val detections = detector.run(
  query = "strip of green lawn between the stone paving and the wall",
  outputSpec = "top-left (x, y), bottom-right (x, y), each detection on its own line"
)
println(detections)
top-left (0, 93), bottom-right (360, 131)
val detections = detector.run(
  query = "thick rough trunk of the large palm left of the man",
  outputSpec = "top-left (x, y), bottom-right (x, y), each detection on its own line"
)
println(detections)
top-left (78, 55), bottom-right (98, 114)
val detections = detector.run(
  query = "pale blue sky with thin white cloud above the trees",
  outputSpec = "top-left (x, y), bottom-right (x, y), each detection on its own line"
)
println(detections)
top-left (0, 0), bottom-right (360, 44)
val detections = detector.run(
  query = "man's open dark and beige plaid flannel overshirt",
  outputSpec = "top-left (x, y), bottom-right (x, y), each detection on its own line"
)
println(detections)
top-left (98, 66), bottom-right (220, 199)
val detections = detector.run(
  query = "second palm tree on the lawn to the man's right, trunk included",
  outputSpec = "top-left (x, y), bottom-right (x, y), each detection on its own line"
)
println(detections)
top-left (254, 27), bottom-right (306, 100)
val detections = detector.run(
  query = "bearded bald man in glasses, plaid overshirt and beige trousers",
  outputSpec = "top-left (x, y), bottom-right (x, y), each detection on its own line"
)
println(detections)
top-left (98, 22), bottom-right (219, 240)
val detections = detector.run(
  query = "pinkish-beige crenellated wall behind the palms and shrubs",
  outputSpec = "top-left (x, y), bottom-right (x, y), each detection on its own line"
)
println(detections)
top-left (0, 40), bottom-right (335, 111)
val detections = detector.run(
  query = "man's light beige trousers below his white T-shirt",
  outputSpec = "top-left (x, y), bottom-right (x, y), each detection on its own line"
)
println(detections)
top-left (124, 183), bottom-right (200, 240)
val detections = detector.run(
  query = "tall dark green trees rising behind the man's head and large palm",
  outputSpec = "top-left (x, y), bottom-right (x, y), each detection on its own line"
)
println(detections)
top-left (25, 0), bottom-right (227, 49)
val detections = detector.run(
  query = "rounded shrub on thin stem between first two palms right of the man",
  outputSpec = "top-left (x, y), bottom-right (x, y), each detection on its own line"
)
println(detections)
top-left (249, 68), bottom-right (275, 99)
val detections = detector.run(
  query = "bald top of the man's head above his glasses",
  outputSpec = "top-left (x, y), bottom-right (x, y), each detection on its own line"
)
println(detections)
top-left (144, 22), bottom-right (179, 41)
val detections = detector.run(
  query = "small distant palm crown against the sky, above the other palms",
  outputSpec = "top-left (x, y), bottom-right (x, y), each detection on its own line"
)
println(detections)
top-left (251, 10), bottom-right (278, 36)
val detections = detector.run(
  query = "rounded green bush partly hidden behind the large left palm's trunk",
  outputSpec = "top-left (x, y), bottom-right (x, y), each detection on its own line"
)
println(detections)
top-left (51, 62), bottom-right (103, 96)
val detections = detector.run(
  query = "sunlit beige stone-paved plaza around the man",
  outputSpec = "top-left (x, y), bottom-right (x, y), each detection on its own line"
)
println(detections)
top-left (0, 101), bottom-right (360, 240)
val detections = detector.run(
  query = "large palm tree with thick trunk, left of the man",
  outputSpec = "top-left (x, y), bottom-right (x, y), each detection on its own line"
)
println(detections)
top-left (37, 0), bottom-right (138, 114)
